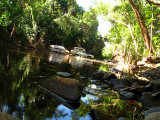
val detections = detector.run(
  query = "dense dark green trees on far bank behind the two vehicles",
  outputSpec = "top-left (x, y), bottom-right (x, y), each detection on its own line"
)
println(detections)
top-left (0, 0), bottom-right (103, 57)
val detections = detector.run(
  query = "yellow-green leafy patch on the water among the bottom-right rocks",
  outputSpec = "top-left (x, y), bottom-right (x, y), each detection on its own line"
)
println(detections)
top-left (92, 93), bottom-right (142, 120)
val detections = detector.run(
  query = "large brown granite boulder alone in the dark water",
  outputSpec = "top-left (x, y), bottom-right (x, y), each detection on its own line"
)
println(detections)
top-left (41, 78), bottom-right (82, 101)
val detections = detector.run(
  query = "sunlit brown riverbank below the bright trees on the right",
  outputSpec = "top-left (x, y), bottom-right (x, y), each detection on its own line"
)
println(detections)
top-left (92, 57), bottom-right (160, 81)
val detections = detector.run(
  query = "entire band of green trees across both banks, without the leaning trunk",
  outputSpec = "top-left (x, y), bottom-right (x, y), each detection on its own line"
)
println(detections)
top-left (0, 0), bottom-right (160, 58)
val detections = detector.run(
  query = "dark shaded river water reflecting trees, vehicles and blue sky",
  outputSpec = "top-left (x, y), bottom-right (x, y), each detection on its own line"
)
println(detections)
top-left (0, 46), bottom-right (115, 120)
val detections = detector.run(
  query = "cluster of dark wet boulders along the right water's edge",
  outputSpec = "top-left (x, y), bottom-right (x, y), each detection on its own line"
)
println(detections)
top-left (92, 70), bottom-right (160, 107)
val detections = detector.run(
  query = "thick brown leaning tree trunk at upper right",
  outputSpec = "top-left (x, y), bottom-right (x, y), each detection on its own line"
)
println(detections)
top-left (129, 0), bottom-right (155, 53)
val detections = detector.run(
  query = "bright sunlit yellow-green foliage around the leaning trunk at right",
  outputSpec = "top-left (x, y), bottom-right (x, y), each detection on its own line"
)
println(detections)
top-left (95, 0), bottom-right (160, 61)
